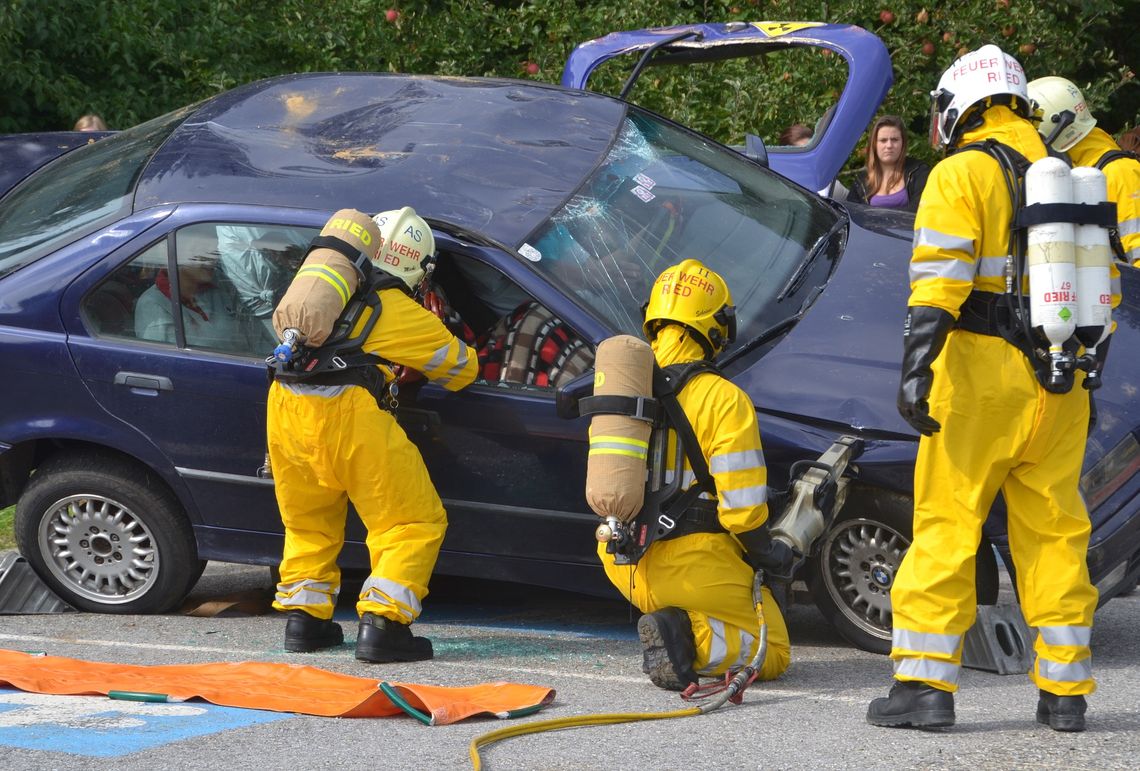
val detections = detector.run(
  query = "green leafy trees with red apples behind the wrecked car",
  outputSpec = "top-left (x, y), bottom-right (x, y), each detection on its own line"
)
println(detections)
top-left (0, 0), bottom-right (1140, 179)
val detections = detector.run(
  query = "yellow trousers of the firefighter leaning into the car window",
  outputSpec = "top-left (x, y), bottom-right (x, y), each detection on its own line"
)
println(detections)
top-left (268, 383), bottom-right (447, 624)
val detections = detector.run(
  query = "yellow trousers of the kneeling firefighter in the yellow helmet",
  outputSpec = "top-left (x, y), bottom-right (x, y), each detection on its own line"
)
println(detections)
top-left (597, 533), bottom-right (791, 680)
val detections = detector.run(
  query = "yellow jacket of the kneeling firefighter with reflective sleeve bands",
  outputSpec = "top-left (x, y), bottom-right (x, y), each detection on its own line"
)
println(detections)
top-left (653, 325), bottom-right (768, 533)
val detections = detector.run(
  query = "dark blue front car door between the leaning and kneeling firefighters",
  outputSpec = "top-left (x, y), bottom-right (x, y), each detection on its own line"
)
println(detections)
top-left (399, 247), bottom-right (597, 567)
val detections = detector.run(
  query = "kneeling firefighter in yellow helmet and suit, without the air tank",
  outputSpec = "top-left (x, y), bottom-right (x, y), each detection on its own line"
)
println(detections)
top-left (599, 260), bottom-right (792, 690)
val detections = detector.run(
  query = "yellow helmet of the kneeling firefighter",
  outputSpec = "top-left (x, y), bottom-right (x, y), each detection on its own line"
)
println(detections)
top-left (642, 260), bottom-right (736, 358)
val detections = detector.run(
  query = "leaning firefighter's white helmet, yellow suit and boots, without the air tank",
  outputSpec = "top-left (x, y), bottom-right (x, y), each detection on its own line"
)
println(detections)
top-left (268, 206), bottom-right (478, 663)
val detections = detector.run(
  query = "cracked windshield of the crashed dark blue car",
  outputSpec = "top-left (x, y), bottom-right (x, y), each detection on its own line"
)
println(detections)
top-left (519, 111), bottom-right (839, 341)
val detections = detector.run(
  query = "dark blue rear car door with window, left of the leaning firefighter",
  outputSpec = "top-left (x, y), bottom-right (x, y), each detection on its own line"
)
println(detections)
top-left (64, 216), bottom-right (316, 561)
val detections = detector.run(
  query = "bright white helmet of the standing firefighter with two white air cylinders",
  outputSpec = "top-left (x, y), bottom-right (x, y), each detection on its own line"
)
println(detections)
top-left (930, 43), bottom-right (1031, 147)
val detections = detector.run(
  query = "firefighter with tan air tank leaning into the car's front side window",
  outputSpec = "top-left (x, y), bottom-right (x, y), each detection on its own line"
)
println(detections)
top-left (268, 206), bottom-right (478, 663)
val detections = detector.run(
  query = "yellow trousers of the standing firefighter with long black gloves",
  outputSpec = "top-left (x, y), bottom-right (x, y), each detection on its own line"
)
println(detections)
top-left (890, 330), bottom-right (1097, 696)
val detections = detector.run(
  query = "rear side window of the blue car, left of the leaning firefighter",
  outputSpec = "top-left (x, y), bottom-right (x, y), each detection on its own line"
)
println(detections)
top-left (82, 222), bottom-right (317, 358)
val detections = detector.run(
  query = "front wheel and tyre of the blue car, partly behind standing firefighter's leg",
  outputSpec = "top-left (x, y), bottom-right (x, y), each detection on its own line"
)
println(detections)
top-left (807, 488), bottom-right (999, 654)
